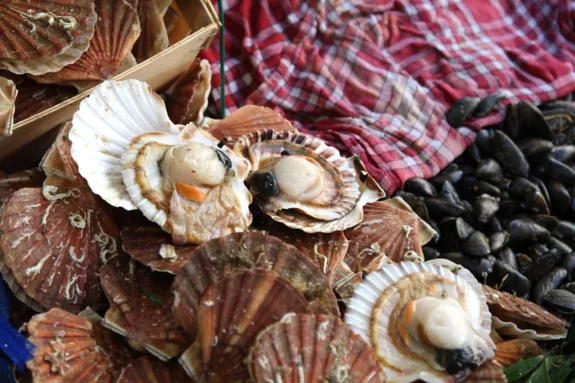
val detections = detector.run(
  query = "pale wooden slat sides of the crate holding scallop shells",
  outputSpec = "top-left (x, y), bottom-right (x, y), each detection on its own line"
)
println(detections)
top-left (0, 0), bottom-right (220, 171)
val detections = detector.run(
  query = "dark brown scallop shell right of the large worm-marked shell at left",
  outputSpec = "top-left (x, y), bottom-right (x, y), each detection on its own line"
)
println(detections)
top-left (100, 257), bottom-right (191, 361)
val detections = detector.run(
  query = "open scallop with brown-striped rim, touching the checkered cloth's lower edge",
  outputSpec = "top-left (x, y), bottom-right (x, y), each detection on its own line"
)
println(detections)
top-left (234, 130), bottom-right (385, 233)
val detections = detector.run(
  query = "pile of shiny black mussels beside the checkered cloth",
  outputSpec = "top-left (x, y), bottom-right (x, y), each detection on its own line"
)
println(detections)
top-left (396, 95), bottom-right (575, 310)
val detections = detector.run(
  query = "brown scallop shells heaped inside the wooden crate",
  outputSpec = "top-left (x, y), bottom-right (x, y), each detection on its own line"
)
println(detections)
top-left (0, 0), bottom-right (187, 136)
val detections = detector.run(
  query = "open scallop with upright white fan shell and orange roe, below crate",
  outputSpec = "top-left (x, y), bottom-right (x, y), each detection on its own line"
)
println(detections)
top-left (70, 80), bottom-right (252, 244)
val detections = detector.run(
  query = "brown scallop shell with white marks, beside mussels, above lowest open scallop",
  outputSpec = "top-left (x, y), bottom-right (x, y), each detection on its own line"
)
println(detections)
top-left (345, 201), bottom-right (423, 271)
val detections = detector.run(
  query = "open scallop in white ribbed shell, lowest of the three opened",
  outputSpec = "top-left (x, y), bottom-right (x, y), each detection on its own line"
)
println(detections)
top-left (345, 262), bottom-right (495, 383)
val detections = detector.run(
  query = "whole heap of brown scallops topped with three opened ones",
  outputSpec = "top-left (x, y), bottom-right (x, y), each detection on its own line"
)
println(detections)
top-left (0, 60), bottom-right (567, 383)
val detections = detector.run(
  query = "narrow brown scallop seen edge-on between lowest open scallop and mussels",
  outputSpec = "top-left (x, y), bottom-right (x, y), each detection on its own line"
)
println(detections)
top-left (483, 285), bottom-right (569, 329)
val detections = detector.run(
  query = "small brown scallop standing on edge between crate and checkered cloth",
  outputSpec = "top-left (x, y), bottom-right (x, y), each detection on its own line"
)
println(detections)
top-left (166, 59), bottom-right (212, 124)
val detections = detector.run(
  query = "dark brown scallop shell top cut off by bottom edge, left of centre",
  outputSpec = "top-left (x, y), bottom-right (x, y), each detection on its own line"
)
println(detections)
top-left (114, 356), bottom-right (192, 383)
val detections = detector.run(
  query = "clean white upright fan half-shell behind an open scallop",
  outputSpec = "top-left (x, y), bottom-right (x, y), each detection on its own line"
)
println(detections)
top-left (70, 80), bottom-right (183, 210)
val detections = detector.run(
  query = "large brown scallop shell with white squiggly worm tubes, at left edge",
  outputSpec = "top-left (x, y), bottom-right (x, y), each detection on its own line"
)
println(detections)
top-left (0, 185), bottom-right (119, 312)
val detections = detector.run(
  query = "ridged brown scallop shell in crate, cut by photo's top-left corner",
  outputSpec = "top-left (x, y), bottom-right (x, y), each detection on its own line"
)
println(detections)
top-left (0, 0), bottom-right (97, 75)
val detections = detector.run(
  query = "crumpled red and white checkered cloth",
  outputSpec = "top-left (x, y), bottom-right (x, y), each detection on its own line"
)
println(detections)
top-left (203, 0), bottom-right (575, 192)
